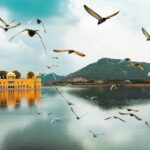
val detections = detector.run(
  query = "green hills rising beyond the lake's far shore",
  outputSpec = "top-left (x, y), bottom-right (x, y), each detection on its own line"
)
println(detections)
top-left (42, 58), bottom-right (150, 82)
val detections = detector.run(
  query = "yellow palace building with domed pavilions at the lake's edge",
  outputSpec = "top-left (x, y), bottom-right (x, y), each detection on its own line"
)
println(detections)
top-left (0, 72), bottom-right (41, 89)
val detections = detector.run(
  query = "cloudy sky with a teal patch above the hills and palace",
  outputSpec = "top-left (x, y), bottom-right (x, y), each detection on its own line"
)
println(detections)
top-left (0, 0), bottom-right (150, 76)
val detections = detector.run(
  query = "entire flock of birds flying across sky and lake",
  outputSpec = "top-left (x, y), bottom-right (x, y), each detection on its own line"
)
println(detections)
top-left (0, 2), bottom-right (150, 138)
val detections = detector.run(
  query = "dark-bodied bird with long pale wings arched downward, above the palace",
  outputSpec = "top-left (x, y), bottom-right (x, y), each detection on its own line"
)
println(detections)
top-left (9, 29), bottom-right (47, 54)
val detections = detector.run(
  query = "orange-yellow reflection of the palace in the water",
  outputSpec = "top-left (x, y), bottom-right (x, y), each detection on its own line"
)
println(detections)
top-left (0, 89), bottom-right (41, 109)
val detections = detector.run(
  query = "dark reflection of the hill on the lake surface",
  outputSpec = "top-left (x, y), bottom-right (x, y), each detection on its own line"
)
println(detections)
top-left (69, 87), bottom-right (150, 109)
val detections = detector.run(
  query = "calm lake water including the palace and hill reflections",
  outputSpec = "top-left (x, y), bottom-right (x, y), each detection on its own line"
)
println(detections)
top-left (0, 87), bottom-right (150, 150)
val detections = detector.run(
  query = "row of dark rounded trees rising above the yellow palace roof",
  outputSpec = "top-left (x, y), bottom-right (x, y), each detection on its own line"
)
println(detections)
top-left (0, 70), bottom-right (34, 79)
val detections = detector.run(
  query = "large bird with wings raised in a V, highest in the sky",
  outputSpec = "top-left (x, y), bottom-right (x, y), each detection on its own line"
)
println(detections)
top-left (84, 5), bottom-right (119, 25)
